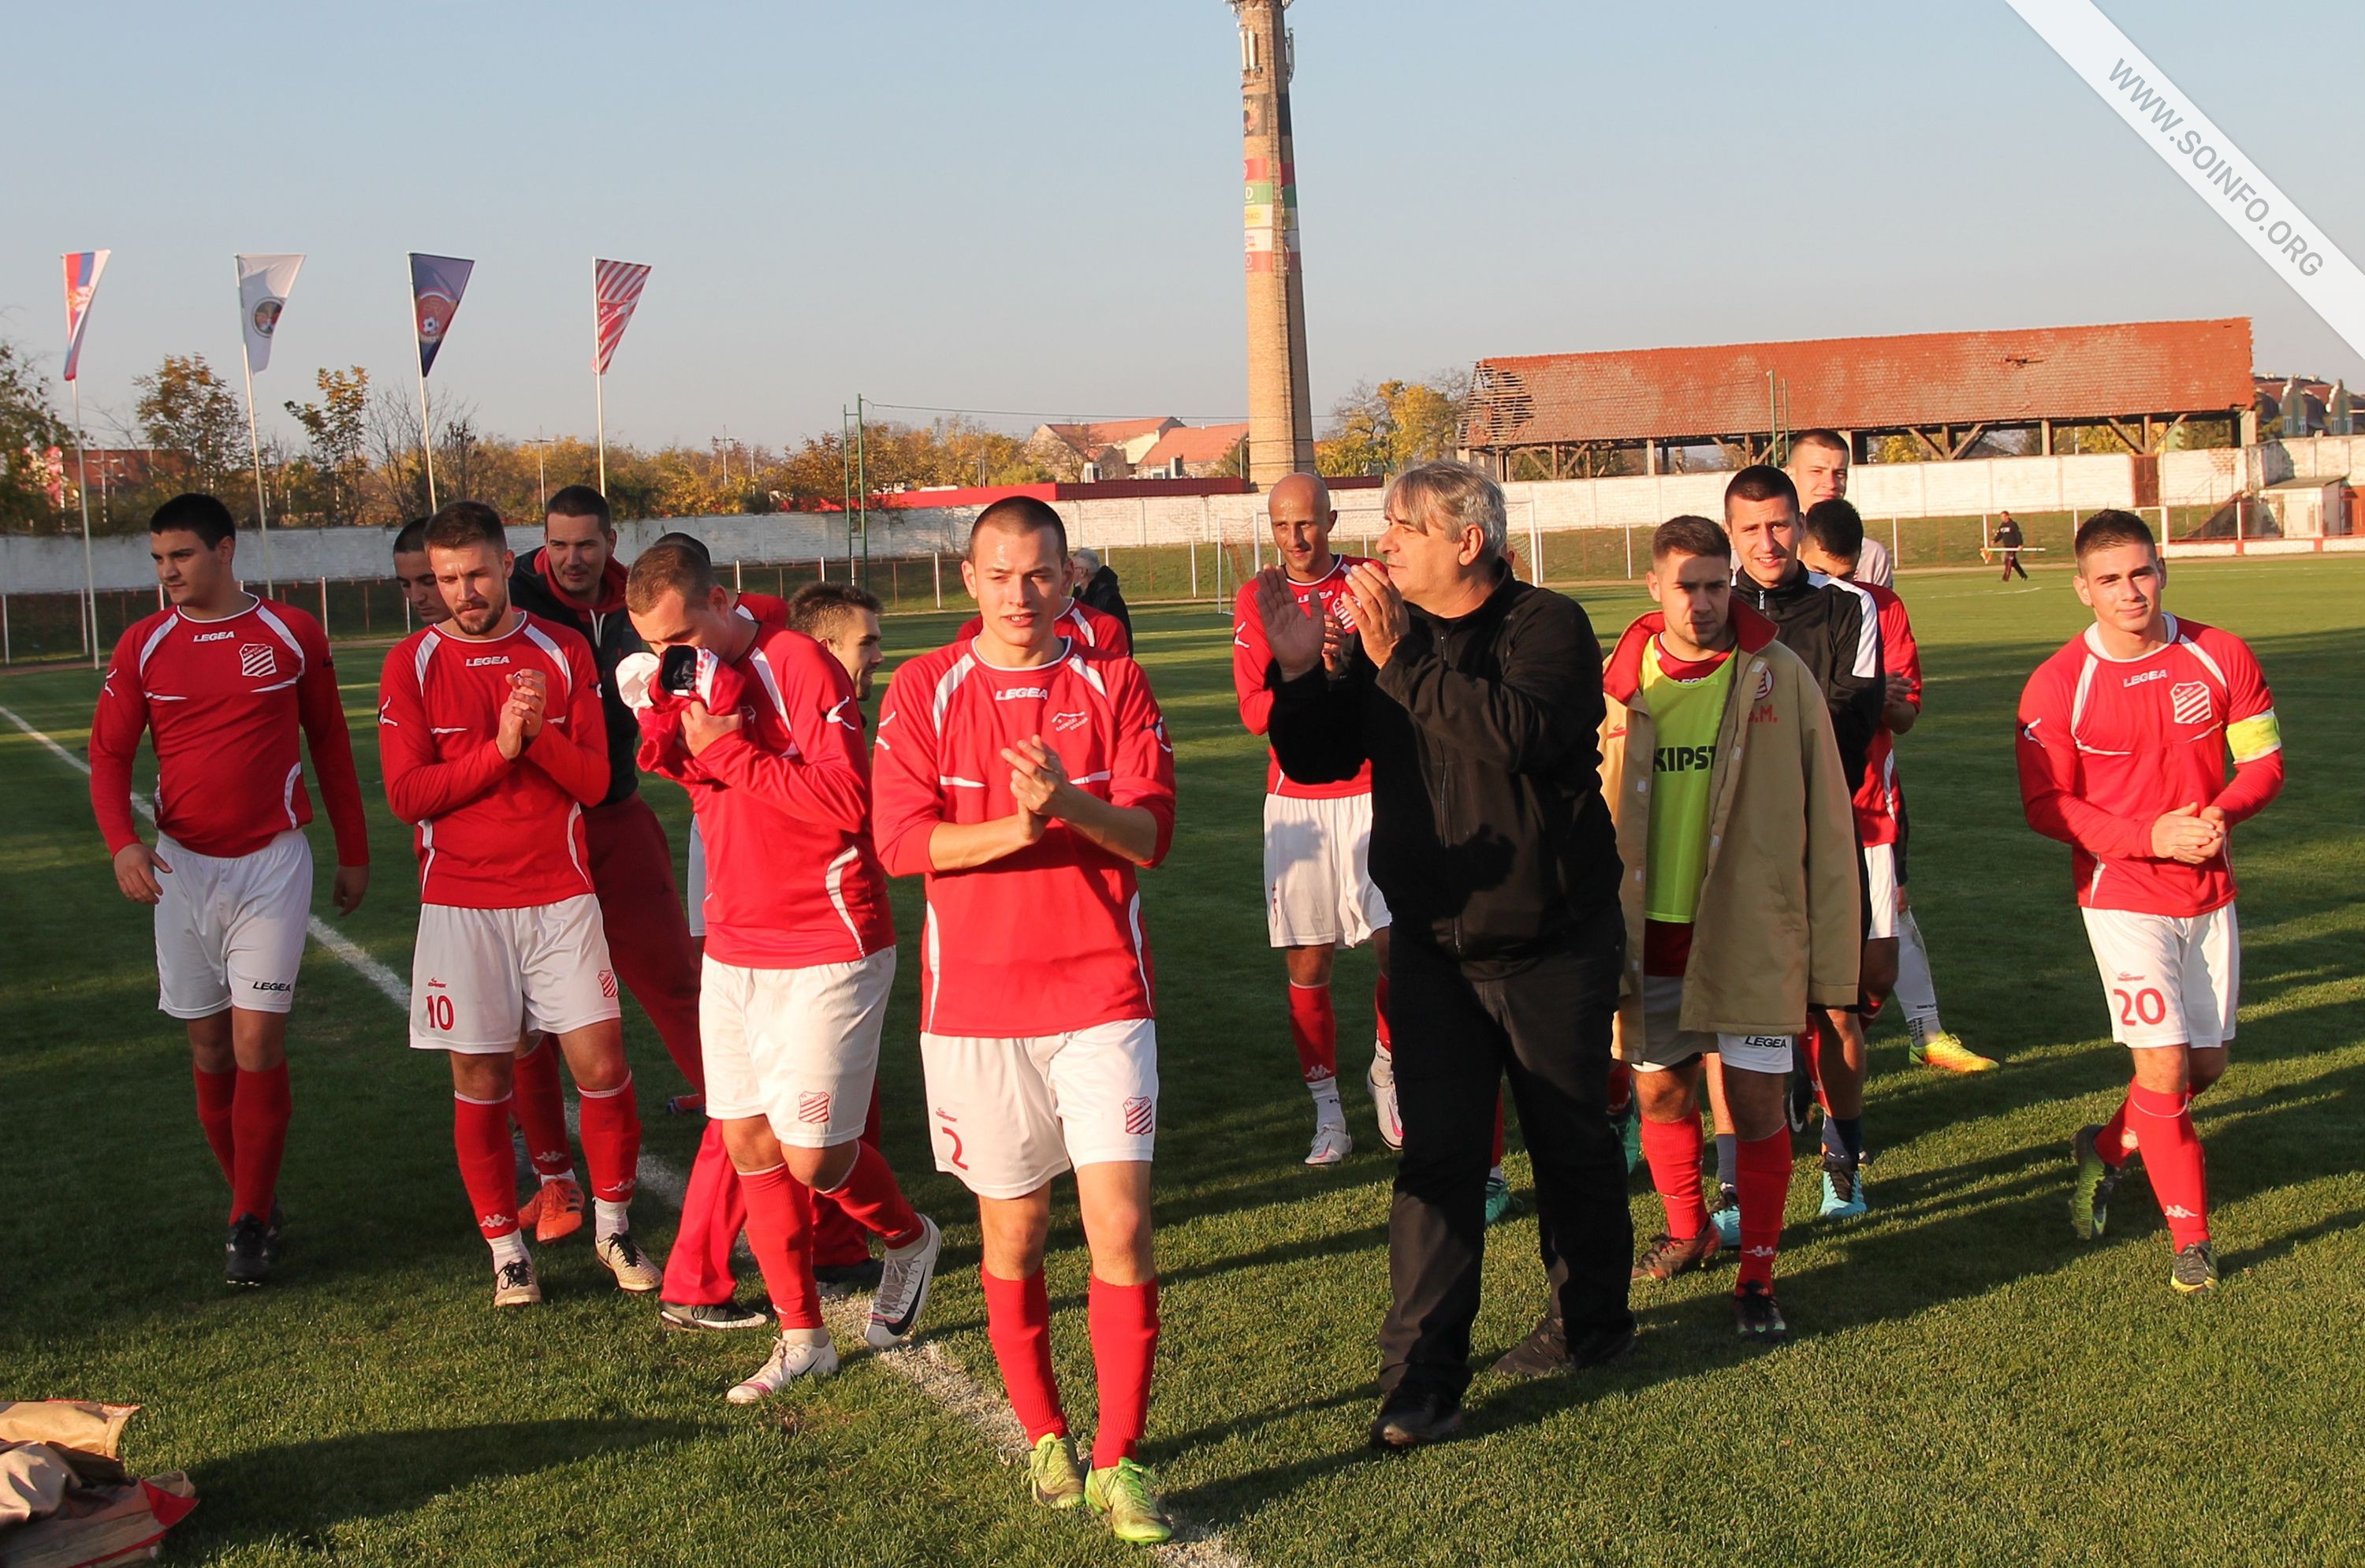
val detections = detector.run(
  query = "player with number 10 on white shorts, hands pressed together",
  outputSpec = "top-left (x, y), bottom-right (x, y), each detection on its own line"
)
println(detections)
top-left (378, 501), bottom-right (660, 1308)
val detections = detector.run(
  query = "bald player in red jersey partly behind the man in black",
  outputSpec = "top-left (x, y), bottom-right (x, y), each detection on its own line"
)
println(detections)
top-left (1232, 473), bottom-right (1405, 1166)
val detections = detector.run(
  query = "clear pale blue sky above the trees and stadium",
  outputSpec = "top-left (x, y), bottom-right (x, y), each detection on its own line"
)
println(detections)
top-left (18, 0), bottom-right (2365, 454)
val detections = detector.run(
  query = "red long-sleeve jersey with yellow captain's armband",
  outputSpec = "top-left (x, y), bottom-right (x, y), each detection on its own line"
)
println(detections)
top-left (2020, 615), bottom-right (2282, 915)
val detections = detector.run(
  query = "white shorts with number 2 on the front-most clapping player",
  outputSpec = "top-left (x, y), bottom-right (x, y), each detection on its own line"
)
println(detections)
top-left (920, 1017), bottom-right (1159, 1197)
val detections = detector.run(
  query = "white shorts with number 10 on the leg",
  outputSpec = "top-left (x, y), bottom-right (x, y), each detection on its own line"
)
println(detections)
top-left (412, 894), bottom-right (622, 1055)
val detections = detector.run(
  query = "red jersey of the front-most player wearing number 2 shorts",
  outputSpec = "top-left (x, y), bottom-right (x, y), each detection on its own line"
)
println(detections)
top-left (875, 639), bottom-right (1175, 1038)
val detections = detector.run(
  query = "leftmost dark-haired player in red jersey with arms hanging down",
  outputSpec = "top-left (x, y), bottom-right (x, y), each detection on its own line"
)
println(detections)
top-left (90, 494), bottom-right (369, 1284)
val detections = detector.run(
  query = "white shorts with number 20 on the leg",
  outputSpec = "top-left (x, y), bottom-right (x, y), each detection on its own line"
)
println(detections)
top-left (2081, 903), bottom-right (2242, 1050)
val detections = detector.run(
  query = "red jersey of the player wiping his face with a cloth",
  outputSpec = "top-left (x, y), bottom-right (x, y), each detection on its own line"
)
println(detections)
top-left (639, 622), bottom-right (894, 970)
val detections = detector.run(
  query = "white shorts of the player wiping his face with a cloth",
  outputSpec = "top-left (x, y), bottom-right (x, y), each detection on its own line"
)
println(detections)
top-left (698, 948), bottom-right (894, 1149)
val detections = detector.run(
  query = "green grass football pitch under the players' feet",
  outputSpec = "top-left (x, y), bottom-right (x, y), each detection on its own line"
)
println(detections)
top-left (0, 561), bottom-right (2365, 1563)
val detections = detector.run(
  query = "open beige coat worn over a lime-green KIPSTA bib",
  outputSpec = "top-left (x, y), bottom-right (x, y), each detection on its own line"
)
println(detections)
top-left (1601, 603), bottom-right (1864, 1057)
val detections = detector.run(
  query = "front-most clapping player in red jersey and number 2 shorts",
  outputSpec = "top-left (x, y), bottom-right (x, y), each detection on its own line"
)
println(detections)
top-left (875, 497), bottom-right (1175, 1542)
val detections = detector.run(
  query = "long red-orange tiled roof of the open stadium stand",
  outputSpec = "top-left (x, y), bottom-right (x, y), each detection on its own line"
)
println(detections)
top-left (1469, 317), bottom-right (2251, 454)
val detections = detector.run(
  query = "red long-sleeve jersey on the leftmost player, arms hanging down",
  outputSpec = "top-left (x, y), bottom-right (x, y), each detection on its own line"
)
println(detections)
top-left (90, 598), bottom-right (369, 866)
